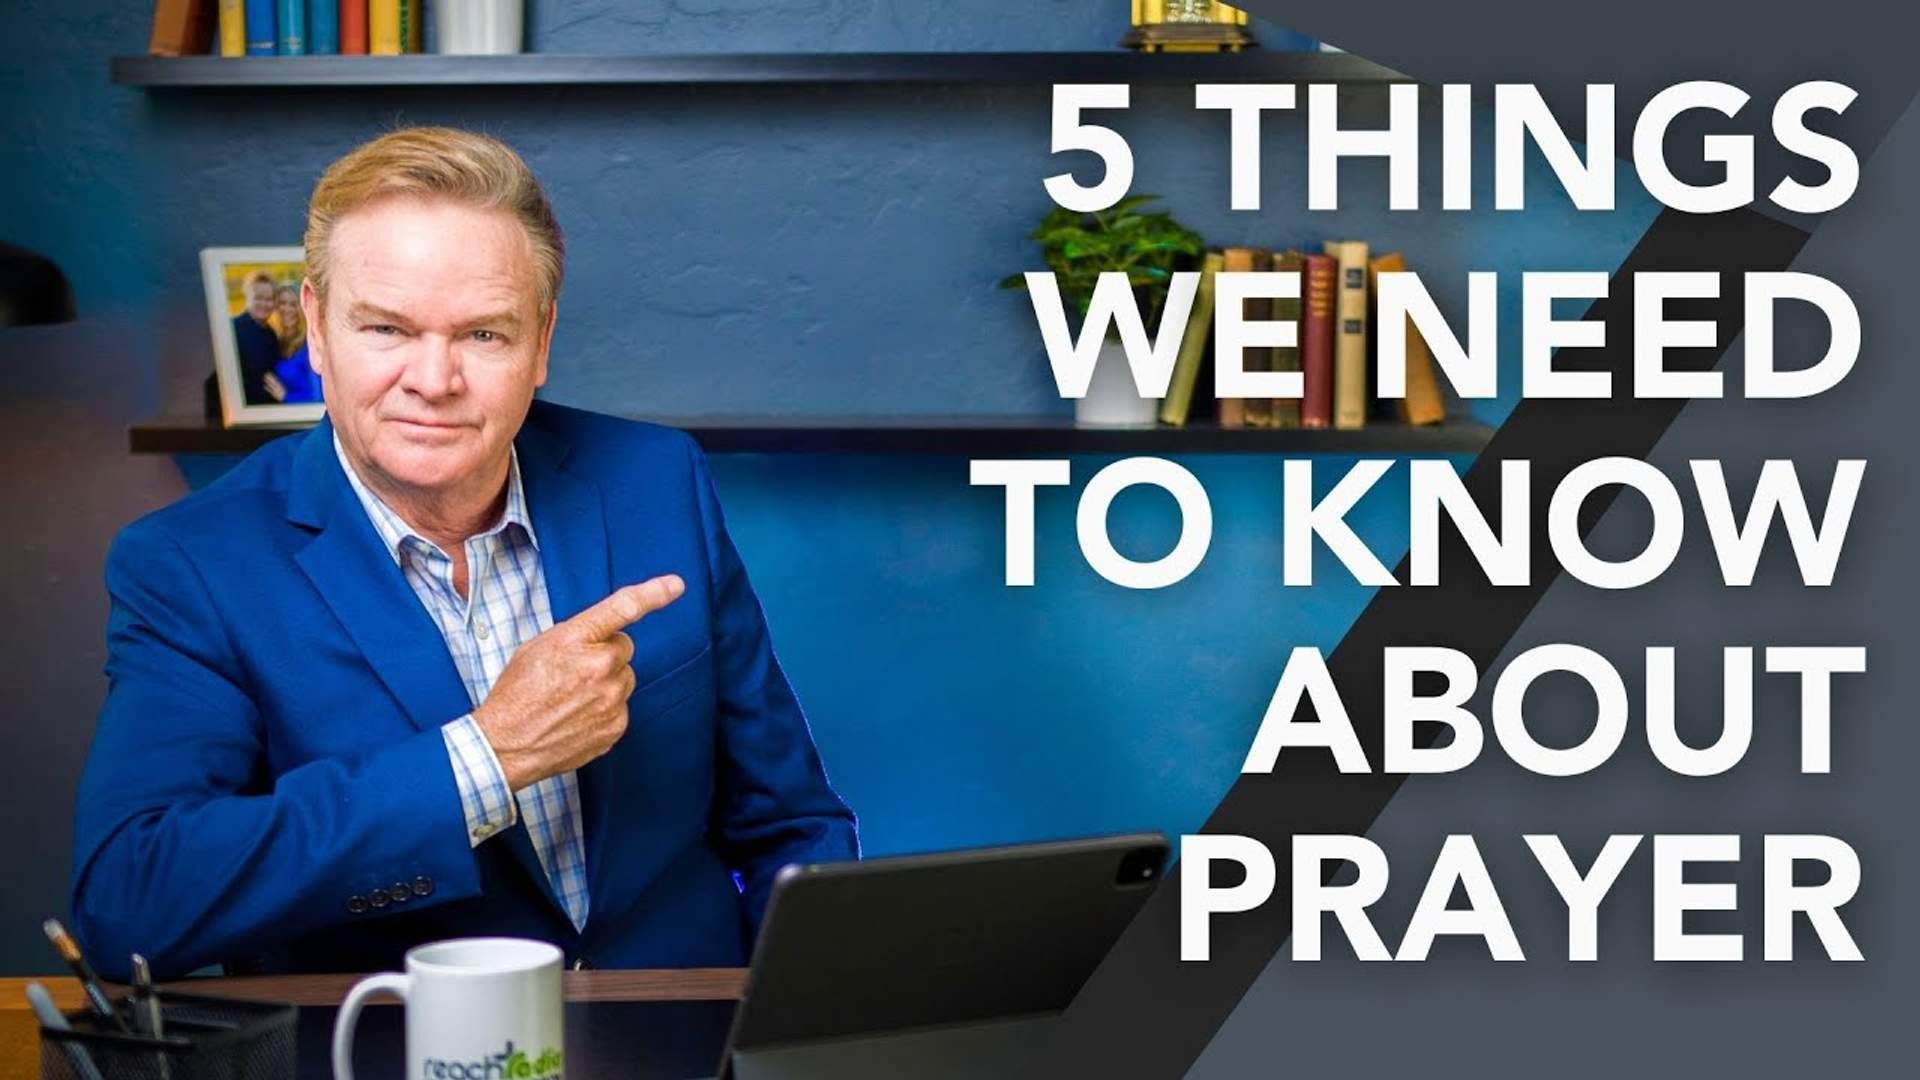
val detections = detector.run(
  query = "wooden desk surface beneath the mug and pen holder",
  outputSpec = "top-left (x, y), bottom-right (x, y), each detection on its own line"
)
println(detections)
top-left (0, 969), bottom-right (747, 1080)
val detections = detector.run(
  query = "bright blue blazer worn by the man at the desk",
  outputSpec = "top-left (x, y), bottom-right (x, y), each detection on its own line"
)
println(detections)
top-left (73, 402), bottom-right (858, 978)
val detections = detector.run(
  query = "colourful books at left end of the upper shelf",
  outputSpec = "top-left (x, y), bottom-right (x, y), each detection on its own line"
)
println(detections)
top-left (146, 0), bottom-right (426, 56)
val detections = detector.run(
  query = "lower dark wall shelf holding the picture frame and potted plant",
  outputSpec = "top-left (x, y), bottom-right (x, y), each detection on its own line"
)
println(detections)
top-left (127, 417), bottom-right (1494, 455)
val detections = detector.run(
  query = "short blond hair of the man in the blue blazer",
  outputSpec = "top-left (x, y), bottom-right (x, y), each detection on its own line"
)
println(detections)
top-left (305, 127), bottom-right (566, 319)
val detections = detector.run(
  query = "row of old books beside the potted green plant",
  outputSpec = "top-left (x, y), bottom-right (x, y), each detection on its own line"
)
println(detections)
top-left (1160, 240), bottom-right (1446, 429)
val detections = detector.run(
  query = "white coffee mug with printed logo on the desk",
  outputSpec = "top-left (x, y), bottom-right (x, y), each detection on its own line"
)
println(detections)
top-left (334, 938), bottom-right (566, 1080)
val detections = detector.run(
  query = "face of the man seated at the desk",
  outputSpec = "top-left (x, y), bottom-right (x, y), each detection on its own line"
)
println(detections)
top-left (301, 198), bottom-right (553, 498)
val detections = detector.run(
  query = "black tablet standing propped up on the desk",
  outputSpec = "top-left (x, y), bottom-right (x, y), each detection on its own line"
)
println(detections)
top-left (720, 834), bottom-right (1167, 1080)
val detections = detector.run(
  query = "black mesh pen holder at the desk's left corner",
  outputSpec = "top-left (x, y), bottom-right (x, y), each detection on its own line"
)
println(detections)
top-left (40, 992), bottom-right (300, 1080)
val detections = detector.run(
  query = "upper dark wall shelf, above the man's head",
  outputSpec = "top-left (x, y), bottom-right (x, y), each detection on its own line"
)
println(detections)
top-left (111, 48), bottom-right (1407, 86)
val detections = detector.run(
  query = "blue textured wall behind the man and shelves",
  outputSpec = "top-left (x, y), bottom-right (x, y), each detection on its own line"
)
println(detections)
top-left (0, 0), bottom-right (1651, 969)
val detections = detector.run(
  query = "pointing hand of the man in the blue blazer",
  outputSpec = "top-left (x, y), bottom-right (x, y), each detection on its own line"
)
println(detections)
top-left (474, 575), bottom-right (687, 792)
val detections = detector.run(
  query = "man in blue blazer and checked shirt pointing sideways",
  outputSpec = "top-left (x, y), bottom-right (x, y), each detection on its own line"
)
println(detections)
top-left (73, 129), bottom-right (858, 976)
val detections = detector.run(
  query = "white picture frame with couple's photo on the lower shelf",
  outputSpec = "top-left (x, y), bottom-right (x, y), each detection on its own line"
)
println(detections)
top-left (200, 244), bottom-right (326, 427)
